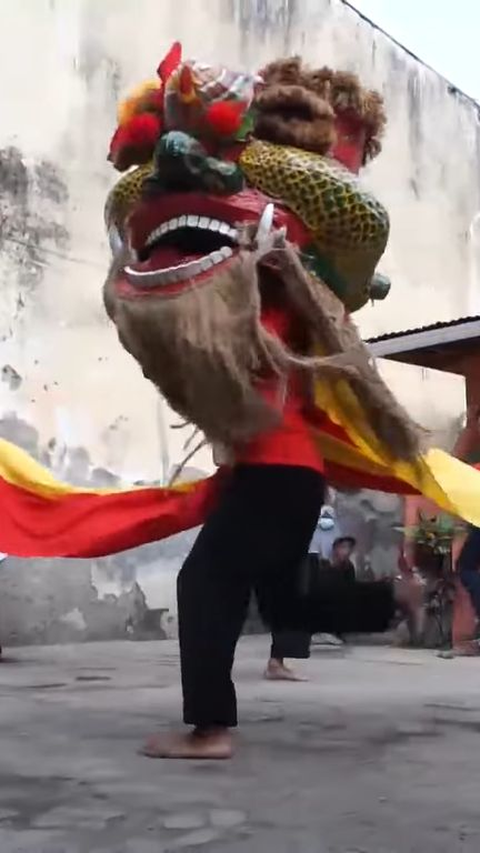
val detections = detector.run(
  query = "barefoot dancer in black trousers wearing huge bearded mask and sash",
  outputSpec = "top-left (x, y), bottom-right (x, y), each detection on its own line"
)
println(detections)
top-left (0, 44), bottom-right (480, 758)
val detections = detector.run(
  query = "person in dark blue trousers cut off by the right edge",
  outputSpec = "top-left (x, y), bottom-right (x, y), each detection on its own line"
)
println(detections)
top-left (453, 404), bottom-right (480, 639)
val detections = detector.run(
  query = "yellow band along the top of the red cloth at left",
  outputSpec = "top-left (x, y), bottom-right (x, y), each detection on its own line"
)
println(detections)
top-left (0, 439), bottom-right (194, 499)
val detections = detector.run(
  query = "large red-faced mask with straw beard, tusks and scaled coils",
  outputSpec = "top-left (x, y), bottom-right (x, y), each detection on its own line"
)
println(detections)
top-left (104, 44), bottom-right (418, 458)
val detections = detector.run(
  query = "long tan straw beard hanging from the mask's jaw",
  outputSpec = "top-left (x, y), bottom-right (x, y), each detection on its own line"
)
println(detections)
top-left (104, 228), bottom-right (421, 460)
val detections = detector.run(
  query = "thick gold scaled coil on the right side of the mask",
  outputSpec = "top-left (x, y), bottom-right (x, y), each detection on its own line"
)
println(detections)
top-left (240, 140), bottom-right (389, 311)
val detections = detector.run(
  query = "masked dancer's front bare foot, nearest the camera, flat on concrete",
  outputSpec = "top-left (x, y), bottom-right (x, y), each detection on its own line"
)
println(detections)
top-left (141, 729), bottom-right (233, 761)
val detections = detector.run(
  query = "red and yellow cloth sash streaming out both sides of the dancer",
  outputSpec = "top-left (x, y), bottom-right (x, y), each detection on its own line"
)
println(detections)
top-left (0, 370), bottom-right (480, 557)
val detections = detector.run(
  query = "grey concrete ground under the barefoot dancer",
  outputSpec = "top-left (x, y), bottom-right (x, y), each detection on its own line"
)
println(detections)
top-left (0, 637), bottom-right (480, 853)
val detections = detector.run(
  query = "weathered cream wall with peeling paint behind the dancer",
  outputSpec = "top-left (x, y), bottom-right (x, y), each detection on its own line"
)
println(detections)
top-left (0, 0), bottom-right (474, 643)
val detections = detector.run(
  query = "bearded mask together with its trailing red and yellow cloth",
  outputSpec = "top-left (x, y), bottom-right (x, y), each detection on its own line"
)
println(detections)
top-left (0, 44), bottom-right (480, 556)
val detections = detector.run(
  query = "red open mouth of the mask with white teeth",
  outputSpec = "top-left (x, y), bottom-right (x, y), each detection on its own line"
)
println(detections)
top-left (118, 189), bottom-right (308, 292)
